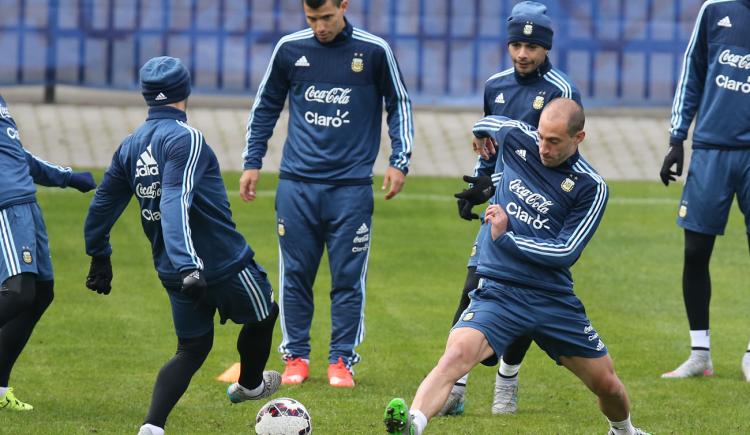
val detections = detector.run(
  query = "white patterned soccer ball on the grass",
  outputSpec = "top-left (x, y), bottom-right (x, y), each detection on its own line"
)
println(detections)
top-left (255, 397), bottom-right (312, 435)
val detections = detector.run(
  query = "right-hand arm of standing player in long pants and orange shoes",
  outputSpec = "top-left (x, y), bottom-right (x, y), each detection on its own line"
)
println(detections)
top-left (380, 44), bottom-right (414, 199)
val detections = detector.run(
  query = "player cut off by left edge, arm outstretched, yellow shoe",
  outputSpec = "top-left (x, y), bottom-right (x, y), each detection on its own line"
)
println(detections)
top-left (0, 96), bottom-right (96, 411)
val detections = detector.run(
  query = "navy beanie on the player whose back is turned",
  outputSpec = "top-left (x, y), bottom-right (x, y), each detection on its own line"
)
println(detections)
top-left (140, 56), bottom-right (190, 106)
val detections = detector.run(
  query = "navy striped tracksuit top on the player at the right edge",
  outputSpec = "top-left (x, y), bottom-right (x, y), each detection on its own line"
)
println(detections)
top-left (669, 0), bottom-right (750, 149)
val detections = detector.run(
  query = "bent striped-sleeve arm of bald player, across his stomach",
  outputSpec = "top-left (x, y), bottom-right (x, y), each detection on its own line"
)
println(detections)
top-left (493, 181), bottom-right (608, 267)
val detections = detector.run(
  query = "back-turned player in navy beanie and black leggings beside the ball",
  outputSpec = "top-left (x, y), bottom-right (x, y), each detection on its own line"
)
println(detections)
top-left (85, 56), bottom-right (281, 435)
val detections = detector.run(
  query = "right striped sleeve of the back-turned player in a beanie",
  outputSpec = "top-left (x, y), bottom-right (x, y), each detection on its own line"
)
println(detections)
top-left (159, 129), bottom-right (207, 273)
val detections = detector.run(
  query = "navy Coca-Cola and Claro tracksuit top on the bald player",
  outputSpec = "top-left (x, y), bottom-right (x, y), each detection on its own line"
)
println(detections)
top-left (474, 116), bottom-right (608, 293)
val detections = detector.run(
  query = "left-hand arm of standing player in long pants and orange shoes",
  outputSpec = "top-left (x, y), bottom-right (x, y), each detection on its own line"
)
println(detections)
top-left (240, 41), bottom-right (290, 201)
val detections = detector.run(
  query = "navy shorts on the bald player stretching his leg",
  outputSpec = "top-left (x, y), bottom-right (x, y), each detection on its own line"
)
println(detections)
top-left (453, 278), bottom-right (607, 365)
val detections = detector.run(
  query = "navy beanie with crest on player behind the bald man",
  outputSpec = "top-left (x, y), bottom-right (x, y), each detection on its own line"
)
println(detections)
top-left (508, 1), bottom-right (553, 50)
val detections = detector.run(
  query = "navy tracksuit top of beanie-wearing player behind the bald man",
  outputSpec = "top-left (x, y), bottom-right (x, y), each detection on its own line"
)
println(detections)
top-left (474, 58), bottom-right (581, 183)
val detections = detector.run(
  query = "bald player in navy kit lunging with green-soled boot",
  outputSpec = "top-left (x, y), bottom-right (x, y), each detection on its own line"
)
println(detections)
top-left (385, 98), bottom-right (642, 435)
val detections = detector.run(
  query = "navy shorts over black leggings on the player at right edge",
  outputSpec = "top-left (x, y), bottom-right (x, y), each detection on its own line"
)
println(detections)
top-left (677, 148), bottom-right (750, 235)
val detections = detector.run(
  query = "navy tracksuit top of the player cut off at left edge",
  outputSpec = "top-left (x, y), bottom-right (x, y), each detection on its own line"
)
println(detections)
top-left (0, 96), bottom-right (73, 209)
